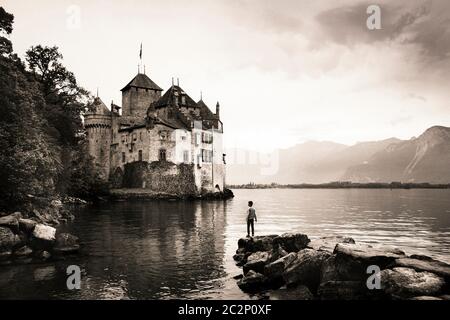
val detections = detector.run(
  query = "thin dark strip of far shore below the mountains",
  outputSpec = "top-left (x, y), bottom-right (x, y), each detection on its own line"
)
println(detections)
top-left (227, 182), bottom-right (450, 189)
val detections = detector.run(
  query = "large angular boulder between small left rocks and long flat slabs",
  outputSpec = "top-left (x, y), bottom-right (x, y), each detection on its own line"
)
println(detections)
top-left (283, 249), bottom-right (330, 293)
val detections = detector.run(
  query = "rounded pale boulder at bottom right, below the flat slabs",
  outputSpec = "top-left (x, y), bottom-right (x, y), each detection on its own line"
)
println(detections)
top-left (380, 267), bottom-right (445, 298)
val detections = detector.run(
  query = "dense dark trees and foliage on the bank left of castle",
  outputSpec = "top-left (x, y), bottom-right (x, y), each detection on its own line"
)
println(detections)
top-left (0, 7), bottom-right (104, 211)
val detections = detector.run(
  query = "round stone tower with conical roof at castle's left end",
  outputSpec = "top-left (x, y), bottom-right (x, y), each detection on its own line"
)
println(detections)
top-left (84, 97), bottom-right (112, 180)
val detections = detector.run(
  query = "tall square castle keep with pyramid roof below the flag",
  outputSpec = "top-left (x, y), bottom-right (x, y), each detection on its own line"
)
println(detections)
top-left (121, 73), bottom-right (162, 119)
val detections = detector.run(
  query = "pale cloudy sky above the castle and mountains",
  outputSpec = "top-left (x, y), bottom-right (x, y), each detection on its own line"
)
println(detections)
top-left (1, 0), bottom-right (450, 151)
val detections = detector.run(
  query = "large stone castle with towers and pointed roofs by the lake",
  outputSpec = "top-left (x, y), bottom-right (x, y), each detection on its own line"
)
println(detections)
top-left (84, 72), bottom-right (225, 195)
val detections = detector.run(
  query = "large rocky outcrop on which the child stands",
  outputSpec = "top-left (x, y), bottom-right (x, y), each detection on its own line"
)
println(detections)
top-left (233, 233), bottom-right (450, 300)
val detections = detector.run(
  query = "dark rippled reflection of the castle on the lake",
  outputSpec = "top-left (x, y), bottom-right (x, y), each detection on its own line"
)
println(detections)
top-left (90, 201), bottom-right (227, 298)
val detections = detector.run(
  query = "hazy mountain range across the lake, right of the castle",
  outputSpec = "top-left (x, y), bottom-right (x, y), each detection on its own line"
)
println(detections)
top-left (227, 126), bottom-right (450, 184)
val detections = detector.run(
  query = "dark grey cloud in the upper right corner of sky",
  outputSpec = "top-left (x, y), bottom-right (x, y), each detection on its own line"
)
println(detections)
top-left (316, 0), bottom-right (450, 61)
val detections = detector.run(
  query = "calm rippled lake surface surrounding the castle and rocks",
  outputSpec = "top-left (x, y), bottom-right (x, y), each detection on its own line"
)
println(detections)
top-left (0, 189), bottom-right (450, 299)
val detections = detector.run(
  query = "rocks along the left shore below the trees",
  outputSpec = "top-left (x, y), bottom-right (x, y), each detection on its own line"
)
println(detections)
top-left (0, 198), bottom-right (82, 265)
